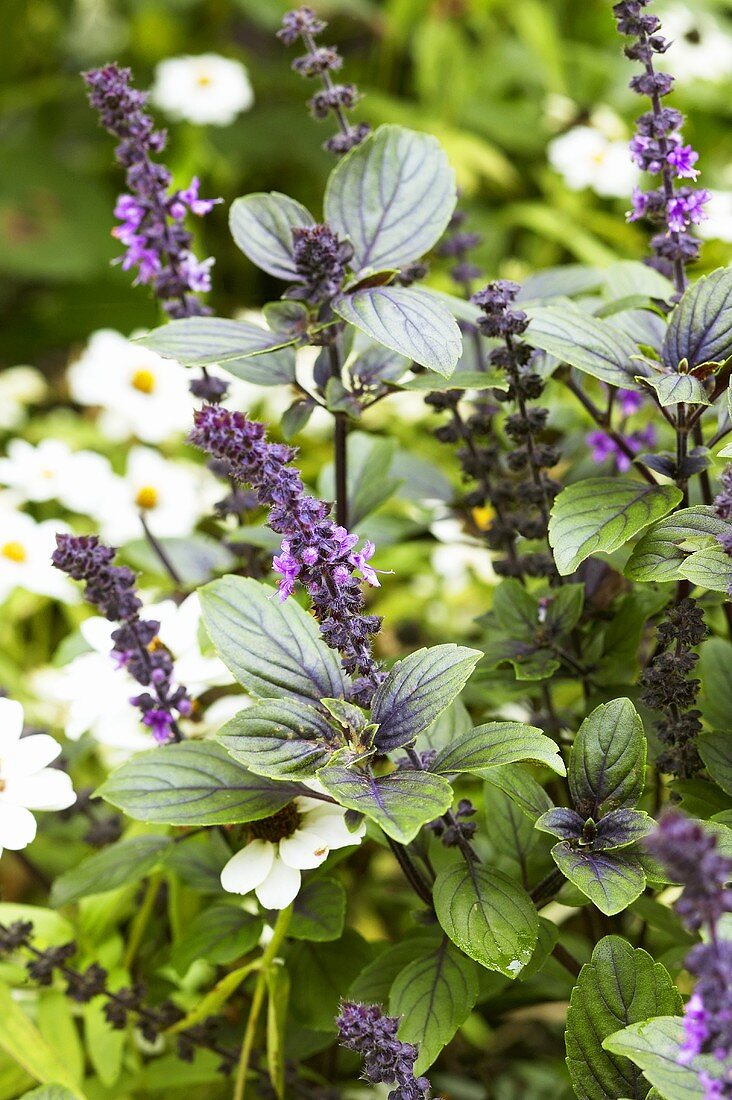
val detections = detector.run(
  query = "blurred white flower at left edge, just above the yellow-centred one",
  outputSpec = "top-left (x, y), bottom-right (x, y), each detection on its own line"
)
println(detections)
top-left (0, 439), bottom-right (118, 515)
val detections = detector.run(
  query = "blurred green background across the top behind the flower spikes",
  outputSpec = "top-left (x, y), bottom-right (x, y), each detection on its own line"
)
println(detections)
top-left (0, 0), bottom-right (732, 372)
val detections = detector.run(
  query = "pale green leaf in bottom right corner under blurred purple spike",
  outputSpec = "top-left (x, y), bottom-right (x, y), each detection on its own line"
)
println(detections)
top-left (602, 1015), bottom-right (724, 1100)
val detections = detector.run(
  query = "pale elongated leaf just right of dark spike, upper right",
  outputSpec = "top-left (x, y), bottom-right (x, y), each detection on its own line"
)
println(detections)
top-left (526, 301), bottom-right (643, 389)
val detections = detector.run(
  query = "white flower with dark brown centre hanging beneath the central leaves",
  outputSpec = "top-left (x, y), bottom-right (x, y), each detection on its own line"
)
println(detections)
top-left (221, 798), bottom-right (365, 909)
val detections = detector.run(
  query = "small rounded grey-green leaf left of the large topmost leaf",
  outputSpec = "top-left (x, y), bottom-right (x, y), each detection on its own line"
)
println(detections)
top-left (229, 191), bottom-right (315, 282)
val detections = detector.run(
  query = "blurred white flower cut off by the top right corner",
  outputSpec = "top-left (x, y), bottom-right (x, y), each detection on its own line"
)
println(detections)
top-left (657, 3), bottom-right (732, 81)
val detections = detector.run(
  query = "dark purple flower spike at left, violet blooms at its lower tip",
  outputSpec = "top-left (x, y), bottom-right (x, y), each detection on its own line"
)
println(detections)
top-left (52, 535), bottom-right (192, 745)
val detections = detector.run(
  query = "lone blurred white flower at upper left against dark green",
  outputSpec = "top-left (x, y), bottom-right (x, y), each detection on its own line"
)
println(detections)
top-left (152, 54), bottom-right (254, 127)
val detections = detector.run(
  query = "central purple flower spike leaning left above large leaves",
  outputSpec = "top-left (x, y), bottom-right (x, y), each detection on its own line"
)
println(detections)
top-left (190, 405), bottom-right (382, 702)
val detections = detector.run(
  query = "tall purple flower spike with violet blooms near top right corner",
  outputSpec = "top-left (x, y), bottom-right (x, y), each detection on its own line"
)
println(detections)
top-left (613, 0), bottom-right (710, 292)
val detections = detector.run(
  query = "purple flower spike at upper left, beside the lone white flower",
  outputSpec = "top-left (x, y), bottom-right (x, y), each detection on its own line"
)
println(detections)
top-left (85, 65), bottom-right (217, 317)
